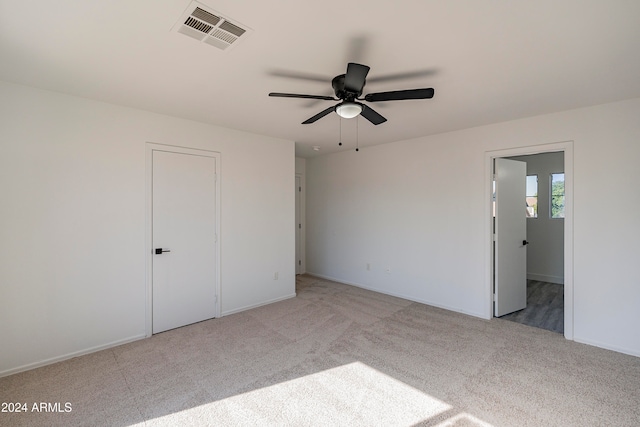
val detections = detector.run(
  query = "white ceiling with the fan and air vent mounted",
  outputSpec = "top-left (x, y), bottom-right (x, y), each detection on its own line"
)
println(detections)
top-left (0, 0), bottom-right (640, 157)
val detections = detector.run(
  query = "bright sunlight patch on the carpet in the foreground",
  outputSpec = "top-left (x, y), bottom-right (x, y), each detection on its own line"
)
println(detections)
top-left (149, 362), bottom-right (496, 427)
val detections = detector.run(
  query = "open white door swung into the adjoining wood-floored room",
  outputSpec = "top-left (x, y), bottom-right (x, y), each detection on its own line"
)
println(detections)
top-left (494, 158), bottom-right (527, 317)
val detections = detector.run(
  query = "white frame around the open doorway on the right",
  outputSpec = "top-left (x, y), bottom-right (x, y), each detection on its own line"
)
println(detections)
top-left (485, 141), bottom-right (574, 340)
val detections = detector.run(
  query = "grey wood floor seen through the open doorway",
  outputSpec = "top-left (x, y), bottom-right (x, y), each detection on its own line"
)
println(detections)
top-left (500, 280), bottom-right (564, 334)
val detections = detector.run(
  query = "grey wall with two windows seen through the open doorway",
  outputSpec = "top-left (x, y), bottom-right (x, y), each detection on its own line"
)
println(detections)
top-left (510, 152), bottom-right (564, 284)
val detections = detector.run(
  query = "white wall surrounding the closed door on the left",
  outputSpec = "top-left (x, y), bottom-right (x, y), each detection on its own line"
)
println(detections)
top-left (0, 83), bottom-right (295, 375)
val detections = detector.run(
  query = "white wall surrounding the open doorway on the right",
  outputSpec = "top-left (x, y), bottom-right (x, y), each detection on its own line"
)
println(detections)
top-left (307, 99), bottom-right (640, 356)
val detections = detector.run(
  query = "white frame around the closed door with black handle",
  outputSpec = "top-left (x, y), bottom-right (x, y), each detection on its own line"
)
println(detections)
top-left (145, 142), bottom-right (222, 338)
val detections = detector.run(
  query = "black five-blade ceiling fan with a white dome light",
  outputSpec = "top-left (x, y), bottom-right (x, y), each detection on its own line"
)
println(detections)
top-left (269, 62), bottom-right (434, 125)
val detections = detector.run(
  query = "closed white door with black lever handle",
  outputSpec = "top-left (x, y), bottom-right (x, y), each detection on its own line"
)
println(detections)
top-left (152, 150), bottom-right (217, 333)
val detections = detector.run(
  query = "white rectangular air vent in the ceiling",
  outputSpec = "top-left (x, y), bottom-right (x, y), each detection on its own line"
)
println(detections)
top-left (173, 1), bottom-right (251, 50)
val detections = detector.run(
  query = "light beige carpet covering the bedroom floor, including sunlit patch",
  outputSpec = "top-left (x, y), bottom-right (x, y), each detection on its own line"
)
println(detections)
top-left (0, 276), bottom-right (640, 427)
